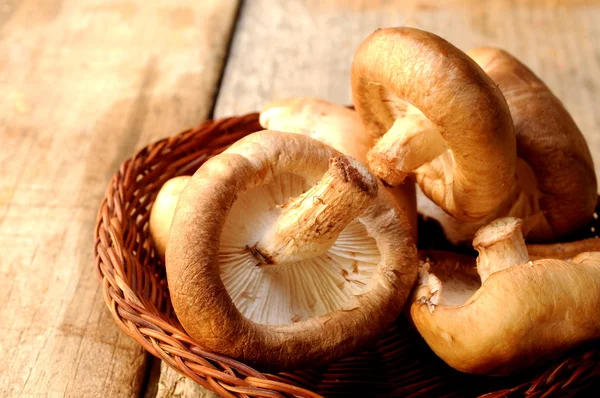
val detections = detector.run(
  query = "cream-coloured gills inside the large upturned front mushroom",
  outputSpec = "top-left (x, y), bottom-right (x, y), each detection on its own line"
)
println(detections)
top-left (219, 174), bottom-right (380, 325)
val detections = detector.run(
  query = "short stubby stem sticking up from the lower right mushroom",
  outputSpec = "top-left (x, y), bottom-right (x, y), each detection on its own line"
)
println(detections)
top-left (473, 217), bottom-right (529, 283)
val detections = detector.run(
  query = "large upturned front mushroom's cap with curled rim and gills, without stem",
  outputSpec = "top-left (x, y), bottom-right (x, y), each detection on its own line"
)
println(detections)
top-left (166, 131), bottom-right (416, 369)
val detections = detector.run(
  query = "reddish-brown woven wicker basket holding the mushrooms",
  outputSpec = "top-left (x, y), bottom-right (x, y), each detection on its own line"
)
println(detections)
top-left (94, 113), bottom-right (600, 397)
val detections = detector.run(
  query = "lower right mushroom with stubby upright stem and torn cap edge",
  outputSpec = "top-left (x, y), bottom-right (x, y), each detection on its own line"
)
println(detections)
top-left (411, 218), bottom-right (600, 375)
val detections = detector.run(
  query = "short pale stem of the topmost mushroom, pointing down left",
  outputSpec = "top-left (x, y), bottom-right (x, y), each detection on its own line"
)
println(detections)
top-left (367, 114), bottom-right (447, 186)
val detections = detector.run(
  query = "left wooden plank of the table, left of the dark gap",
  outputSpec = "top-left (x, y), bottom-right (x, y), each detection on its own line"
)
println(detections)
top-left (0, 0), bottom-right (238, 397)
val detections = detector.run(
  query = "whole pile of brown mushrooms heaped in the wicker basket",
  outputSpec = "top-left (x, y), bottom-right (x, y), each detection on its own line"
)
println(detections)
top-left (150, 28), bottom-right (600, 375)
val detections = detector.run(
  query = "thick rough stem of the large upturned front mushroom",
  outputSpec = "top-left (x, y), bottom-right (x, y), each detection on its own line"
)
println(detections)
top-left (248, 156), bottom-right (378, 264)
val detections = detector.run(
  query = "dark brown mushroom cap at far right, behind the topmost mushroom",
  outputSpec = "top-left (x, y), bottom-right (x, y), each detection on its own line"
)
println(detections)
top-left (468, 47), bottom-right (598, 241)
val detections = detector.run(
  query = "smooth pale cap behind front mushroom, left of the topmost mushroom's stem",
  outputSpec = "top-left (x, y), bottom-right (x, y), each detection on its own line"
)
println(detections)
top-left (260, 97), bottom-right (417, 239)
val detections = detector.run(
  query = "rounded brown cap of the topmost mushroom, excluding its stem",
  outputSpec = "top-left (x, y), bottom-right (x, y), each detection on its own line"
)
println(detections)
top-left (352, 28), bottom-right (516, 220)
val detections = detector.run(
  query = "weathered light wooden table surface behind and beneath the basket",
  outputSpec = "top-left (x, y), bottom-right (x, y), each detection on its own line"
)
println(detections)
top-left (0, 0), bottom-right (600, 397)
